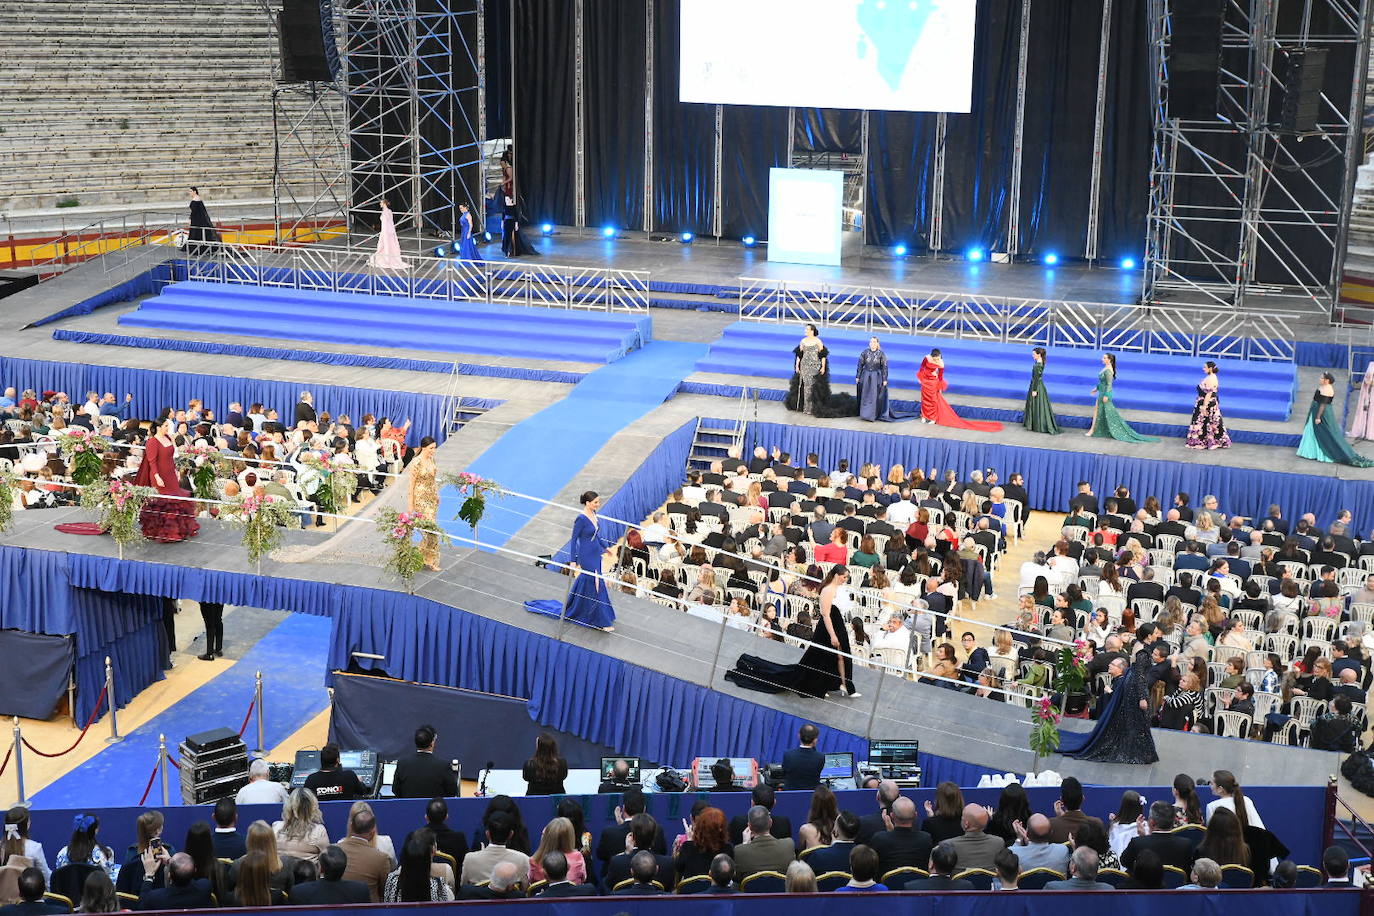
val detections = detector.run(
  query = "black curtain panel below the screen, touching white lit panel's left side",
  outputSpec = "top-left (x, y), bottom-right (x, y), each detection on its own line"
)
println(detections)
top-left (720, 104), bottom-right (787, 239)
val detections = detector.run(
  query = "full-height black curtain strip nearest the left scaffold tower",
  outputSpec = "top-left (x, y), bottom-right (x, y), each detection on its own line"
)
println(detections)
top-left (511, 0), bottom-right (574, 225)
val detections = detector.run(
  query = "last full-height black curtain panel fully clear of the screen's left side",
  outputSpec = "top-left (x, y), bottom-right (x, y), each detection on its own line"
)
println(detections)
top-left (583, 0), bottom-right (643, 231)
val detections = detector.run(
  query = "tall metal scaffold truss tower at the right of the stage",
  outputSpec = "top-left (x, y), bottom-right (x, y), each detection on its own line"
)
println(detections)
top-left (1143, 0), bottom-right (1371, 316)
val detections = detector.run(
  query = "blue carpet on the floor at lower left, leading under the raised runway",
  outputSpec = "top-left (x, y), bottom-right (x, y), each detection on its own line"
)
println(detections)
top-left (33, 614), bottom-right (331, 808)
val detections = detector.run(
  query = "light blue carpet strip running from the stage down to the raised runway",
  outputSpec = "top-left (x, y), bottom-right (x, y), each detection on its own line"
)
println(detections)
top-left (438, 341), bottom-right (706, 553)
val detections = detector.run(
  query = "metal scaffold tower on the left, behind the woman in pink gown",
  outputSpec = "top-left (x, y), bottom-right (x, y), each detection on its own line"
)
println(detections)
top-left (337, 0), bottom-right (485, 250)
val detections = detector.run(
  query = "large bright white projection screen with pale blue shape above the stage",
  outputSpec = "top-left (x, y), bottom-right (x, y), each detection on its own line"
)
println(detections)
top-left (679, 0), bottom-right (977, 111)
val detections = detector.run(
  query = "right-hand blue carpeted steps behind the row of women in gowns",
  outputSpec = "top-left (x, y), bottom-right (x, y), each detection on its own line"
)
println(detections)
top-left (697, 321), bottom-right (1297, 422)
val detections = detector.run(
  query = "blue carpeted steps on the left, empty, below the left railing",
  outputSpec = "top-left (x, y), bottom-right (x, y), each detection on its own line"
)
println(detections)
top-left (120, 280), bottom-right (653, 363)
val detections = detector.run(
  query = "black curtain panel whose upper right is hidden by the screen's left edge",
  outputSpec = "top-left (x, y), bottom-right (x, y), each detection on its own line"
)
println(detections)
top-left (651, 0), bottom-right (724, 235)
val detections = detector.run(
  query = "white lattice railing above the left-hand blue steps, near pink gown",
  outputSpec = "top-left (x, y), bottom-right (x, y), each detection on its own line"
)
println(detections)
top-left (174, 243), bottom-right (649, 312)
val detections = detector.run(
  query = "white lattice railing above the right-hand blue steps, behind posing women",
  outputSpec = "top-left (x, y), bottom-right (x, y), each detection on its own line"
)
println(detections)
top-left (739, 277), bottom-right (1303, 363)
